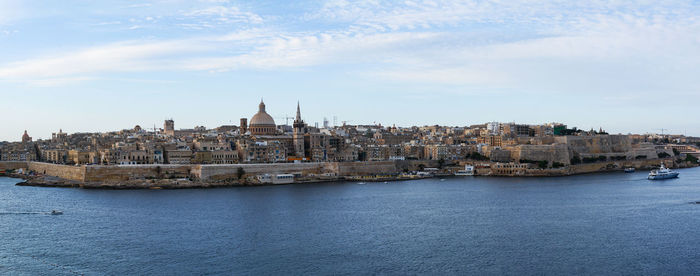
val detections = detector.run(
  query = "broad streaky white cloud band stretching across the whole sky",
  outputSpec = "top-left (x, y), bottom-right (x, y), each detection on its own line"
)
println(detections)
top-left (0, 0), bottom-right (700, 96)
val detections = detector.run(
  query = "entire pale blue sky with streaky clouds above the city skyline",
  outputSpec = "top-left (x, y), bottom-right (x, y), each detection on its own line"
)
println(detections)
top-left (0, 0), bottom-right (700, 141)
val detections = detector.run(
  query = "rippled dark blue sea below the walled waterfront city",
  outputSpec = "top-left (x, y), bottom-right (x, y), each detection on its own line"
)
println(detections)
top-left (0, 168), bottom-right (700, 275)
